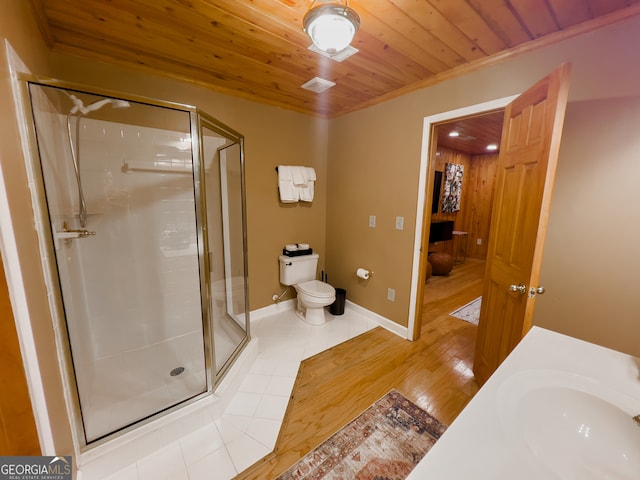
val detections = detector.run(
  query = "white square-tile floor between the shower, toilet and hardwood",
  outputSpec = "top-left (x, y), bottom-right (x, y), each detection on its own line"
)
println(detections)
top-left (87, 306), bottom-right (377, 480)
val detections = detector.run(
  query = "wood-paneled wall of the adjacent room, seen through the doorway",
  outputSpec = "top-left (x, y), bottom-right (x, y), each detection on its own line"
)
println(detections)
top-left (429, 148), bottom-right (498, 260)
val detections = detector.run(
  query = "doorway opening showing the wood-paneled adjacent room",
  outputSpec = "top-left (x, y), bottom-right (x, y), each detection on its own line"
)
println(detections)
top-left (422, 109), bottom-right (504, 342)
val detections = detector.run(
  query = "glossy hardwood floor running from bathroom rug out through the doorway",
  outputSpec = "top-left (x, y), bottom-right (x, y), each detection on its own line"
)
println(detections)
top-left (236, 259), bottom-right (484, 480)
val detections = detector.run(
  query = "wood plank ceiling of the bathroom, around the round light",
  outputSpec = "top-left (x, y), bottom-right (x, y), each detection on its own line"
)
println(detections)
top-left (31, 0), bottom-right (640, 118)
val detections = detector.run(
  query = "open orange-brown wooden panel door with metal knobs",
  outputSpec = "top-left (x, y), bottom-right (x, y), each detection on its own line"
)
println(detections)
top-left (473, 64), bottom-right (570, 384)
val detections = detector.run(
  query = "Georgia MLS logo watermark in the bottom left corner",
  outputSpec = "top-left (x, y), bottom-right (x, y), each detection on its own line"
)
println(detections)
top-left (0, 456), bottom-right (71, 480)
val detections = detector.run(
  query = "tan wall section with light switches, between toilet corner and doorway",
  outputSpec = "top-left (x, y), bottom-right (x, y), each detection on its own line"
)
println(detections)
top-left (327, 109), bottom-right (422, 326)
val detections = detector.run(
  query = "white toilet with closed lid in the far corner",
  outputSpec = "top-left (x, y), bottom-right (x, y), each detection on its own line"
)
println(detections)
top-left (279, 253), bottom-right (336, 325)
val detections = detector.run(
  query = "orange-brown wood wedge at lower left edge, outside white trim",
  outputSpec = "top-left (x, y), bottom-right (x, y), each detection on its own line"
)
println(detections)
top-left (0, 260), bottom-right (40, 456)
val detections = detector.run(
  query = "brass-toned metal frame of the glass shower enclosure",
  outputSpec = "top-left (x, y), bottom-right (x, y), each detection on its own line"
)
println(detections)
top-left (18, 73), bottom-right (251, 453)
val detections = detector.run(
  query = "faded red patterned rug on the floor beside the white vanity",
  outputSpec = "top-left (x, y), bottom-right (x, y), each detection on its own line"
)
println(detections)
top-left (277, 390), bottom-right (447, 480)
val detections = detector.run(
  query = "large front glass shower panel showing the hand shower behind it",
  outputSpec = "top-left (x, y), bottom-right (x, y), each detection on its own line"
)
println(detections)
top-left (29, 84), bottom-right (208, 443)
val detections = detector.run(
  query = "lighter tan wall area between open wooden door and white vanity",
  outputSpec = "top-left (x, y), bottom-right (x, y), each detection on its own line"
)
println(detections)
top-left (534, 97), bottom-right (640, 357)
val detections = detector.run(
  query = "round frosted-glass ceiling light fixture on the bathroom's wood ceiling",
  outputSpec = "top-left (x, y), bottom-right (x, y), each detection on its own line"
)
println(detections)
top-left (302, 0), bottom-right (360, 55)
